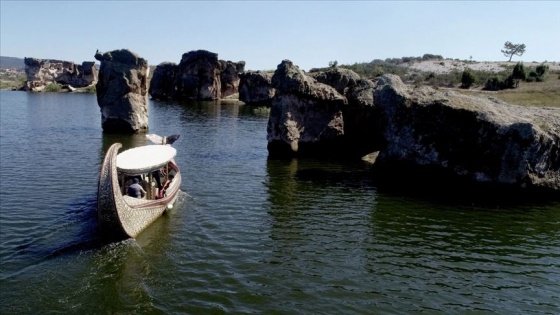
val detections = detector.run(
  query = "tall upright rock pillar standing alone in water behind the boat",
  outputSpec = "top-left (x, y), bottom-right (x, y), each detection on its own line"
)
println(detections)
top-left (95, 49), bottom-right (149, 133)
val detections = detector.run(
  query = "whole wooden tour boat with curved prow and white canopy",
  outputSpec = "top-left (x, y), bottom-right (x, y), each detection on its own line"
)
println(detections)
top-left (97, 143), bottom-right (181, 240)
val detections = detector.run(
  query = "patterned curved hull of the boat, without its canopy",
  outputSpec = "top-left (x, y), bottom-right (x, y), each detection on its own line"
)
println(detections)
top-left (97, 143), bottom-right (181, 240)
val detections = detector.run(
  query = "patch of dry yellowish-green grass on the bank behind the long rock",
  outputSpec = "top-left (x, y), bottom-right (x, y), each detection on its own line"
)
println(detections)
top-left (457, 73), bottom-right (560, 108)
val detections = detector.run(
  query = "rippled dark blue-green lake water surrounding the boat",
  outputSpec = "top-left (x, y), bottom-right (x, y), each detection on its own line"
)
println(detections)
top-left (0, 91), bottom-right (560, 314)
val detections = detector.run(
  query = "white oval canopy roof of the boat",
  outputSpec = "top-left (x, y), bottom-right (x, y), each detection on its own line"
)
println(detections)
top-left (117, 145), bottom-right (177, 174)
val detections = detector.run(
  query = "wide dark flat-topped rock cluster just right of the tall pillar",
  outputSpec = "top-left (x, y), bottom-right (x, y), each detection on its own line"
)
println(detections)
top-left (149, 50), bottom-right (245, 100)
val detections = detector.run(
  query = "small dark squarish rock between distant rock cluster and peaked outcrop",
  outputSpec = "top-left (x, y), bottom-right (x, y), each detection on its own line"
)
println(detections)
top-left (239, 71), bottom-right (275, 106)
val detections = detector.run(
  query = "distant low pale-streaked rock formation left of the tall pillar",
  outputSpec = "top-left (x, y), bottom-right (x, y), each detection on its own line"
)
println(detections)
top-left (24, 58), bottom-right (98, 92)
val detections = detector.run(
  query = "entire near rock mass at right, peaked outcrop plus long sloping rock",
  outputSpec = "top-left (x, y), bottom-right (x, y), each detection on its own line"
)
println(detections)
top-left (267, 60), bottom-right (560, 192)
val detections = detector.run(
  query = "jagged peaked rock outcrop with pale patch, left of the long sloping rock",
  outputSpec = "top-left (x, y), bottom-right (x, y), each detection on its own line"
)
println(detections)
top-left (267, 60), bottom-right (346, 156)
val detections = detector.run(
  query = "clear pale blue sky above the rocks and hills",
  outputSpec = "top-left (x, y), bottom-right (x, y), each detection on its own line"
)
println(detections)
top-left (0, 0), bottom-right (560, 71)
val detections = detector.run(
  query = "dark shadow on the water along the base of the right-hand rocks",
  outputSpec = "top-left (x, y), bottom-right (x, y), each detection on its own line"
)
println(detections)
top-left (268, 158), bottom-right (560, 209)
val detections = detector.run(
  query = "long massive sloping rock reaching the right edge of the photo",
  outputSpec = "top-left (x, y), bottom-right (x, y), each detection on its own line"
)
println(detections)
top-left (375, 75), bottom-right (560, 192)
